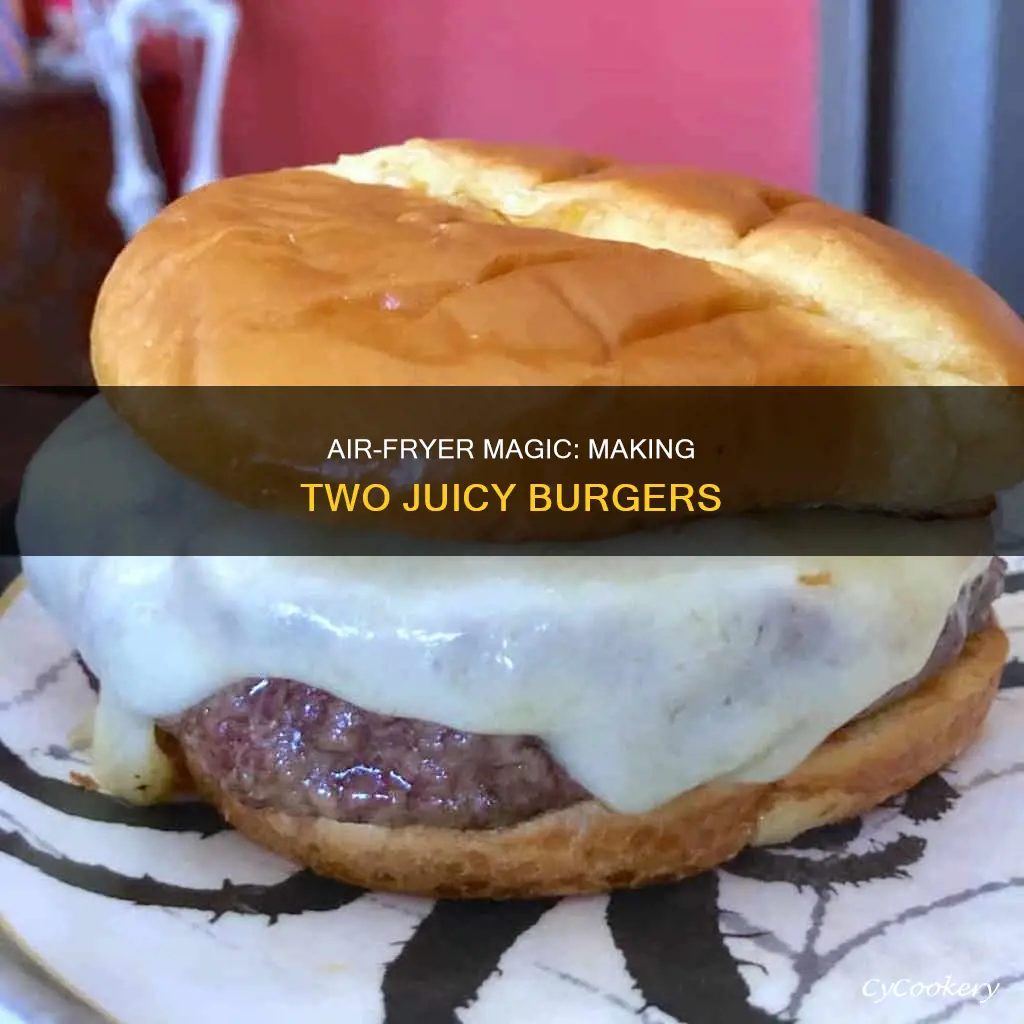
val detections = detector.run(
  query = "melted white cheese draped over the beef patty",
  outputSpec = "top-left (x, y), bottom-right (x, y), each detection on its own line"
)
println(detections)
top-left (18, 399), bottom-right (988, 812)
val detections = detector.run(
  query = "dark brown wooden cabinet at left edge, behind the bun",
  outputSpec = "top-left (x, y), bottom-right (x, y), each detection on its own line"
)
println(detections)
top-left (0, 70), bottom-right (174, 387)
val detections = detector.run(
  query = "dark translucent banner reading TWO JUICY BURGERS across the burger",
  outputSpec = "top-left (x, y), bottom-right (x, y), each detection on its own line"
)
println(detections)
top-left (3, 386), bottom-right (1024, 555)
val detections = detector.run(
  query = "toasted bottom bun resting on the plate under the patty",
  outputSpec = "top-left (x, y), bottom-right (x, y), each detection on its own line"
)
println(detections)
top-left (184, 626), bottom-right (1009, 898)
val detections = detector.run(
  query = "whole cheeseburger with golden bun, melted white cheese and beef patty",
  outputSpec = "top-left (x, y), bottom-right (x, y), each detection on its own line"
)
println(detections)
top-left (12, 140), bottom-right (1024, 897)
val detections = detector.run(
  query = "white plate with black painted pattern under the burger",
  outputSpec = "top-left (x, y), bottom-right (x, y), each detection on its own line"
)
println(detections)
top-left (0, 566), bottom-right (1024, 1024)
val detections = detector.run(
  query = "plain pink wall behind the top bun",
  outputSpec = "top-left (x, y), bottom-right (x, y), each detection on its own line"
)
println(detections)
top-left (218, 0), bottom-right (818, 188)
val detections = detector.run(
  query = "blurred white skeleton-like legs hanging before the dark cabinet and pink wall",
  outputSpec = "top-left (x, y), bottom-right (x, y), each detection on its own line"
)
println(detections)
top-left (74, 0), bottom-right (239, 238)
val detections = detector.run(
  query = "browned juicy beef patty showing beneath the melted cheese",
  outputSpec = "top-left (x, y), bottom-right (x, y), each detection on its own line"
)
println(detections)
top-left (81, 558), bottom-right (1005, 829)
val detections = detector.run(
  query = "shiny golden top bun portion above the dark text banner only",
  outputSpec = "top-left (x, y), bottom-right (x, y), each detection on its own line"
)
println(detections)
top-left (92, 139), bottom-right (1024, 385)
